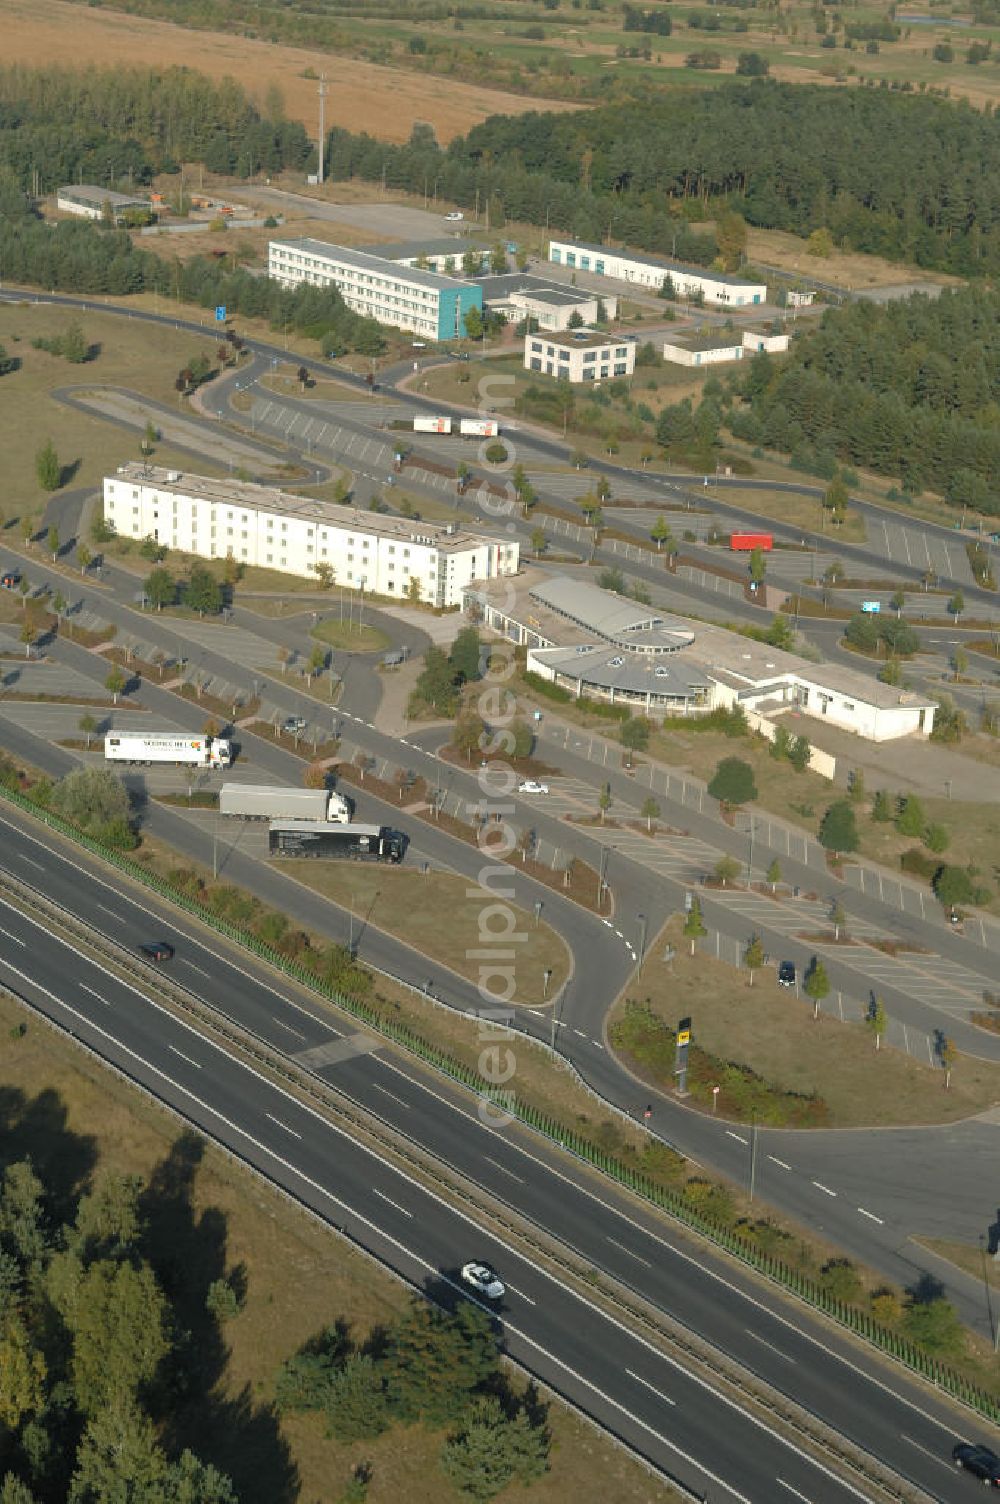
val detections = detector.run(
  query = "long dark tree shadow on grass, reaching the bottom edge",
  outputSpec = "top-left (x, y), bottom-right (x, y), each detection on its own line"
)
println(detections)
top-left (141, 1131), bottom-right (298, 1504)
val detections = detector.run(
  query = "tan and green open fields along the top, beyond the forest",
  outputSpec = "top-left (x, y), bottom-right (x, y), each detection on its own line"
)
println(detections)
top-left (19, 0), bottom-right (1000, 114)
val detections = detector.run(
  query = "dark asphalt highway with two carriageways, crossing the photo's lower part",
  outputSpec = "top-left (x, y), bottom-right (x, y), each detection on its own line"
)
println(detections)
top-left (0, 812), bottom-right (967, 1504)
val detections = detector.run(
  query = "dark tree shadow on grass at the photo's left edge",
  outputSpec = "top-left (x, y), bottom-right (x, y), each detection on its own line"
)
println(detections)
top-left (0, 1086), bottom-right (98, 1226)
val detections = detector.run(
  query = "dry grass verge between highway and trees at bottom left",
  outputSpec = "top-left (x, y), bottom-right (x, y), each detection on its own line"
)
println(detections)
top-left (0, 997), bottom-right (674, 1504)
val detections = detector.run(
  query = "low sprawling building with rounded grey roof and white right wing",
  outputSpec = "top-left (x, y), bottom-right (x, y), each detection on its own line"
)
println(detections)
top-left (465, 567), bottom-right (937, 741)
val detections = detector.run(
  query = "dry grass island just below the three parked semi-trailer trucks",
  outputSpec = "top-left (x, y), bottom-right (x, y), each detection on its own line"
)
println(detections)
top-left (281, 862), bottom-right (570, 1003)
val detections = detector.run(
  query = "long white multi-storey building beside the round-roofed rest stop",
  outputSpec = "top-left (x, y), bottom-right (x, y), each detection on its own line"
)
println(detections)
top-left (104, 462), bottom-right (519, 606)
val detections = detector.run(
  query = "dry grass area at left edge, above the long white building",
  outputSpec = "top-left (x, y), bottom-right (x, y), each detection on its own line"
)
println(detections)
top-left (0, 302), bottom-right (223, 519)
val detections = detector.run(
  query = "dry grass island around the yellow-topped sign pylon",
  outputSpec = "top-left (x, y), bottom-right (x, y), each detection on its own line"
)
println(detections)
top-left (612, 917), bottom-right (1000, 1128)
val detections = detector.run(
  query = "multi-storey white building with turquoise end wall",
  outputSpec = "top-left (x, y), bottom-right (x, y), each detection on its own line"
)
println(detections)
top-left (268, 236), bottom-right (483, 340)
